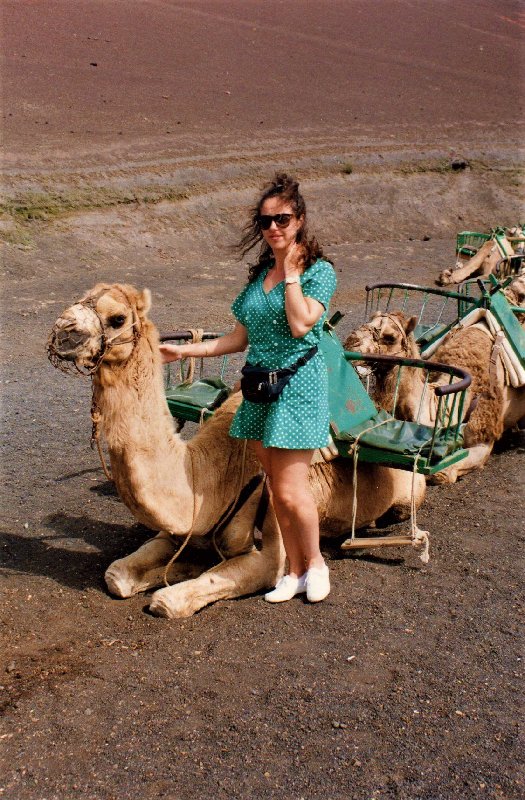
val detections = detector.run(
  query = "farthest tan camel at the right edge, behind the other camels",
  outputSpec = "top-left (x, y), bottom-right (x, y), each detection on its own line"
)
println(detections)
top-left (436, 227), bottom-right (525, 286)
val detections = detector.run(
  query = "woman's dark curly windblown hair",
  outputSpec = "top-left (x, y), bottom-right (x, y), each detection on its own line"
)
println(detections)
top-left (234, 172), bottom-right (329, 283)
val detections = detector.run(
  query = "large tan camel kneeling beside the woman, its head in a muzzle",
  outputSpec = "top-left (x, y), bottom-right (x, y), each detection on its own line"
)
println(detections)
top-left (48, 284), bottom-right (425, 618)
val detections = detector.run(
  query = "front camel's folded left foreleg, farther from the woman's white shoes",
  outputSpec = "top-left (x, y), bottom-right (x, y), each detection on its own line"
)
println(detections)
top-left (104, 532), bottom-right (205, 597)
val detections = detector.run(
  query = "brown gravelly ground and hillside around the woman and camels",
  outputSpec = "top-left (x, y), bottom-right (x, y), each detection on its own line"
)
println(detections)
top-left (0, 0), bottom-right (525, 800)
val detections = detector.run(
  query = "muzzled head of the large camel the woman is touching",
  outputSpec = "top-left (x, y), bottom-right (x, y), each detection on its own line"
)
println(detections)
top-left (47, 283), bottom-right (151, 375)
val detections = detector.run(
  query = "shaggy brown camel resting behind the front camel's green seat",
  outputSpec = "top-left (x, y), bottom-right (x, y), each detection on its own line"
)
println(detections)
top-left (344, 304), bottom-right (525, 483)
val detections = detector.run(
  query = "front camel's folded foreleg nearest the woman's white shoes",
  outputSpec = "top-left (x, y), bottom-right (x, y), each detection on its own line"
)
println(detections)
top-left (149, 507), bottom-right (285, 619)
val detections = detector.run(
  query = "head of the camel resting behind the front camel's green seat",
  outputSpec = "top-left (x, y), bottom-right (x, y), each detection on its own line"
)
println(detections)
top-left (344, 311), bottom-right (417, 357)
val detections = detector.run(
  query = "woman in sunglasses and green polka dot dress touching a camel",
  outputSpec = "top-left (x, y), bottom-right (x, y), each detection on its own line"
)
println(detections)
top-left (161, 175), bottom-right (336, 603)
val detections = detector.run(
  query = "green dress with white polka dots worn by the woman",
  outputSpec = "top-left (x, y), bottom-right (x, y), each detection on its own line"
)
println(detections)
top-left (230, 260), bottom-right (336, 450)
